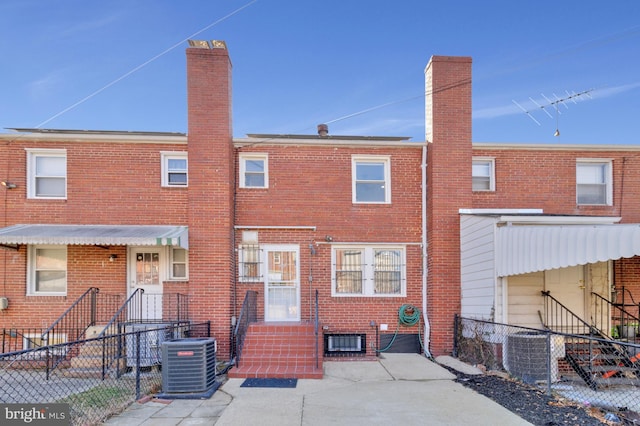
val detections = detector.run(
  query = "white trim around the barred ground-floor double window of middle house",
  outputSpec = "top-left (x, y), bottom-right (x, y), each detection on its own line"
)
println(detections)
top-left (331, 244), bottom-right (407, 298)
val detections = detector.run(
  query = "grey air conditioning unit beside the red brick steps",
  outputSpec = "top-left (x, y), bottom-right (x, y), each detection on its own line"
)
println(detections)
top-left (162, 338), bottom-right (217, 397)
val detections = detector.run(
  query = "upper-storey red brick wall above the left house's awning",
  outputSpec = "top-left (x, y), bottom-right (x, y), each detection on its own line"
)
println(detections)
top-left (0, 141), bottom-right (187, 226)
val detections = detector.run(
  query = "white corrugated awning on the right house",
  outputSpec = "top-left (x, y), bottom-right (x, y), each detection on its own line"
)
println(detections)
top-left (495, 224), bottom-right (640, 277)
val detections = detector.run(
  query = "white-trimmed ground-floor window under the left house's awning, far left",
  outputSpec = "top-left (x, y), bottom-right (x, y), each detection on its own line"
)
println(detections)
top-left (27, 245), bottom-right (67, 296)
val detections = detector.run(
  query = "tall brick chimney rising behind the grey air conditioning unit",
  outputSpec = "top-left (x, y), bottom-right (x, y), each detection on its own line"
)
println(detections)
top-left (186, 41), bottom-right (235, 358)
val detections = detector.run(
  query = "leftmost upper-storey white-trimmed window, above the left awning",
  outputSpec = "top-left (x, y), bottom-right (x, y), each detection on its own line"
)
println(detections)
top-left (26, 149), bottom-right (67, 198)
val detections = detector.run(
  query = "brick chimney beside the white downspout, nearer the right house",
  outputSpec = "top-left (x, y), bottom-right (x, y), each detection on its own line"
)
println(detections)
top-left (425, 56), bottom-right (472, 355)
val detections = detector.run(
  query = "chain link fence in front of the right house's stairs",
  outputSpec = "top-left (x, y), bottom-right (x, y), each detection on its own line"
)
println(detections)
top-left (454, 317), bottom-right (640, 413)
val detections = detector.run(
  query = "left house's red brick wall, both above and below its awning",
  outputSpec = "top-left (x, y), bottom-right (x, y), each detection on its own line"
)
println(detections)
top-left (0, 135), bottom-right (187, 328)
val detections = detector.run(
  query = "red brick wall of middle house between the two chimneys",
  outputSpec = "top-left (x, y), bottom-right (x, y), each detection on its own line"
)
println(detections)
top-left (236, 145), bottom-right (422, 354)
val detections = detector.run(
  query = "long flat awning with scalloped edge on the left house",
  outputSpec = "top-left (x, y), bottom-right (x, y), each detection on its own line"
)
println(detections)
top-left (0, 224), bottom-right (189, 249)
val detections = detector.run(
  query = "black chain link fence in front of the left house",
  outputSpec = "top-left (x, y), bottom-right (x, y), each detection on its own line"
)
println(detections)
top-left (0, 322), bottom-right (211, 425)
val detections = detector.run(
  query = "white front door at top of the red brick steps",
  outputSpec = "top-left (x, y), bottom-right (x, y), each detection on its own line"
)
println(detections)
top-left (264, 246), bottom-right (300, 321)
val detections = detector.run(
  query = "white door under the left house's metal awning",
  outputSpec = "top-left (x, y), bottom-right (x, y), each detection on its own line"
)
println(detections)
top-left (129, 248), bottom-right (165, 321)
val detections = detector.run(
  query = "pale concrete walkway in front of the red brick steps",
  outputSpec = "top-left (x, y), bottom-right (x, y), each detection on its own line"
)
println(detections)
top-left (105, 354), bottom-right (530, 426)
